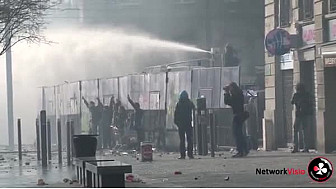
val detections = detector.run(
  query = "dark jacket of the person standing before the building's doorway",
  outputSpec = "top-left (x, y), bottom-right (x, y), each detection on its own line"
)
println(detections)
top-left (291, 92), bottom-right (314, 116)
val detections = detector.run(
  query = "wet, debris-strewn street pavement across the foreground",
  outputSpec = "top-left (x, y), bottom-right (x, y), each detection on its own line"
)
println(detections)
top-left (0, 150), bottom-right (336, 187)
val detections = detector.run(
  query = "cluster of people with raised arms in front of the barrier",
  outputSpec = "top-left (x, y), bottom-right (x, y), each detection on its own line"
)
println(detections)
top-left (82, 95), bottom-right (144, 149)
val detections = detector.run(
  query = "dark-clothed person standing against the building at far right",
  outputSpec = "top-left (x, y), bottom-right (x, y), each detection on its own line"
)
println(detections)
top-left (291, 83), bottom-right (314, 153)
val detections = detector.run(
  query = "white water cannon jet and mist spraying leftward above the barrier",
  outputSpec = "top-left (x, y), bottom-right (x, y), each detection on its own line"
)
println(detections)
top-left (0, 28), bottom-right (208, 143)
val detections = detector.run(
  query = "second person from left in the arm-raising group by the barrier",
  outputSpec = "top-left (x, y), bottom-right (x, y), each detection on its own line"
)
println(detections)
top-left (99, 96), bottom-right (114, 149)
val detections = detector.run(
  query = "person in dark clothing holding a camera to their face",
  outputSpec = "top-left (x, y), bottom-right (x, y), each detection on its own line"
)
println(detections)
top-left (224, 82), bottom-right (249, 157)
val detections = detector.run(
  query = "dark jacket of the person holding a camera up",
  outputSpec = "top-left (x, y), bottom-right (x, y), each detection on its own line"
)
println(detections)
top-left (224, 93), bottom-right (244, 115)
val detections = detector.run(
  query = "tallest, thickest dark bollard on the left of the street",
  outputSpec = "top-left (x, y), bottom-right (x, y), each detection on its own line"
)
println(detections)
top-left (40, 110), bottom-right (48, 167)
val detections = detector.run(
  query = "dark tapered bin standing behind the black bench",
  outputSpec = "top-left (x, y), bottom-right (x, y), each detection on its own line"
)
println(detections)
top-left (73, 135), bottom-right (98, 157)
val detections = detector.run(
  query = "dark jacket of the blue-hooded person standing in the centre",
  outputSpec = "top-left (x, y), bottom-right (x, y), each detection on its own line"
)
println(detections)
top-left (174, 99), bottom-right (195, 127)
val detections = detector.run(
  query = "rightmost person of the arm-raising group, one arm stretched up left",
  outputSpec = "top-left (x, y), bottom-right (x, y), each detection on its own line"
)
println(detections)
top-left (127, 95), bottom-right (145, 149)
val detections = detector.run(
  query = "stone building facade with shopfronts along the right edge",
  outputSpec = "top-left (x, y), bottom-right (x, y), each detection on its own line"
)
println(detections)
top-left (264, 0), bottom-right (336, 153)
